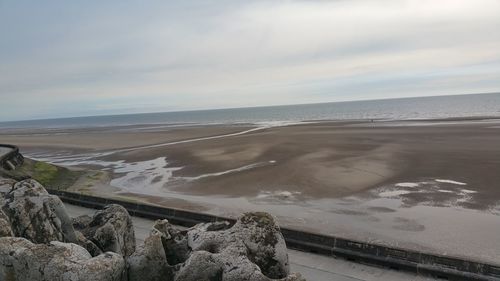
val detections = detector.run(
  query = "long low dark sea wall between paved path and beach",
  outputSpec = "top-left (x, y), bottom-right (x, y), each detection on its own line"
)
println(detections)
top-left (49, 190), bottom-right (500, 280)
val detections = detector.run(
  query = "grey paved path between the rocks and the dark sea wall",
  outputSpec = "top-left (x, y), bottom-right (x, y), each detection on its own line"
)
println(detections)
top-left (65, 203), bottom-right (435, 281)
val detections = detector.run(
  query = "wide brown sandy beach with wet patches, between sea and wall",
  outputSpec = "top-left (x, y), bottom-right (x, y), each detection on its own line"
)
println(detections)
top-left (0, 119), bottom-right (500, 262)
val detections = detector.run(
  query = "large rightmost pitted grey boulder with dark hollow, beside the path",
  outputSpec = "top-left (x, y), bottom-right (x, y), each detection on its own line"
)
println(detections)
top-left (187, 213), bottom-right (290, 280)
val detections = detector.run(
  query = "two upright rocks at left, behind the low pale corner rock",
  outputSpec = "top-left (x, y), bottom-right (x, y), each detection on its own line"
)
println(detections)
top-left (0, 179), bottom-right (135, 256)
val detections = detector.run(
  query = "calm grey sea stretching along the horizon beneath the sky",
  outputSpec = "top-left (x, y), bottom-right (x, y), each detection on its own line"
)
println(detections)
top-left (0, 93), bottom-right (500, 128)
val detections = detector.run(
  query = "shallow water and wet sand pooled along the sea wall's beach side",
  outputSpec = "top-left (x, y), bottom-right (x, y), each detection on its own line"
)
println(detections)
top-left (29, 148), bottom-right (500, 264)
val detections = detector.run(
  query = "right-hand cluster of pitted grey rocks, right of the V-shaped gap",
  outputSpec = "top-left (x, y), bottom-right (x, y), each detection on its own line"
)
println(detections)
top-left (128, 213), bottom-right (304, 281)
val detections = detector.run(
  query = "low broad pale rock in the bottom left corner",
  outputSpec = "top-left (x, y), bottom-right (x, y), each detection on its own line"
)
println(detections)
top-left (0, 237), bottom-right (125, 281)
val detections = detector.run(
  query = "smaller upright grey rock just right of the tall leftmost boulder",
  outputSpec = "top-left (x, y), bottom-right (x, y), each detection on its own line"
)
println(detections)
top-left (73, 205), bottom-right (135, 257)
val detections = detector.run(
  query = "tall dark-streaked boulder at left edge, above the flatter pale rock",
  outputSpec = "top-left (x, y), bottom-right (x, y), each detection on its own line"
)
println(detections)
top-left (0, 179), bottom-right (76, 243)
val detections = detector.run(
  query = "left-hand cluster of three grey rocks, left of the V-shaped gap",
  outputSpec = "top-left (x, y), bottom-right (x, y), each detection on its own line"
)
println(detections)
top-left (0, 178), bottom-right (135, 281)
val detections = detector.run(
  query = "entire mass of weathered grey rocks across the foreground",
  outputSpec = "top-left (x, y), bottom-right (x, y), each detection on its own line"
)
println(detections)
top-left (0, 178), bottom-right (304, 281)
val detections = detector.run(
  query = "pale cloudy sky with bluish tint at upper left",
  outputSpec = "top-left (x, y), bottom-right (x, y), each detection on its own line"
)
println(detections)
top-left (0, 0), bottom-right (500, 121)
